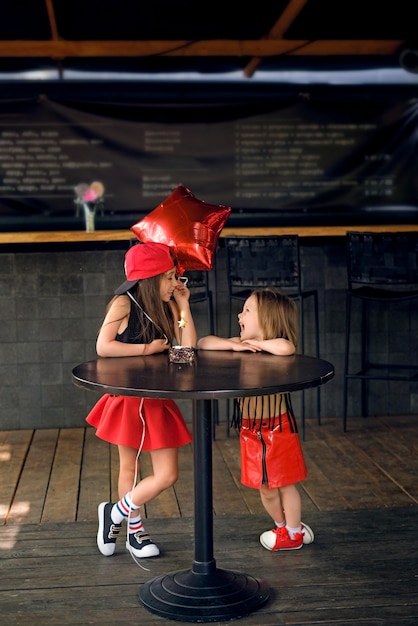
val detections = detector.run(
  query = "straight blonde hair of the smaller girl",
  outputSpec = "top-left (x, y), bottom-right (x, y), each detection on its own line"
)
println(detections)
top-left (251, 287), bottom-right (299, 346)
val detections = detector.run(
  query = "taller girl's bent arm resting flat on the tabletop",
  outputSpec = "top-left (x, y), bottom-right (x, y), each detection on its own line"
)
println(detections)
top-left (96, 296), bottom-right (169, 357)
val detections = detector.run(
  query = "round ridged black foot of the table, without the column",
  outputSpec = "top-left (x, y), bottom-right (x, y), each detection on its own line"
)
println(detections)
top-left (139, 568), bottom-right (270, 622)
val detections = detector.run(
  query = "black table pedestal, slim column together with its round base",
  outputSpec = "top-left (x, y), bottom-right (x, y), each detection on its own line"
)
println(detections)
top-left (139, 400), bottom-right (270, 622)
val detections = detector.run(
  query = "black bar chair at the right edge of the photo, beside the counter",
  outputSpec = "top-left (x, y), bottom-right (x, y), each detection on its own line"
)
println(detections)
top-left (343, 231), bottom-right (418, 431)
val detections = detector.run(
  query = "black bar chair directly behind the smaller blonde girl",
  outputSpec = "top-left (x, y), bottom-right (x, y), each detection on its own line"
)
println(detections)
top-left (222, 235), bottom-right (321, 437)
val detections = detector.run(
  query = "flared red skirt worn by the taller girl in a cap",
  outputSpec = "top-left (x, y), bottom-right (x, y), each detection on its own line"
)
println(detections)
top-left (86, 394), bottom-right (192, 450)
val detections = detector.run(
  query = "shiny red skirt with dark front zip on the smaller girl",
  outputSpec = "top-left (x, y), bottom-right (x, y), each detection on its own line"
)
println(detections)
top-left (240, 414), bottom-right (308, 489)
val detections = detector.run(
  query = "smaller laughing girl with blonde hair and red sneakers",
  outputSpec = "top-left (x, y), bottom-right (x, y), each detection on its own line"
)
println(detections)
top-left (198, 289), bottom-right (314, 551)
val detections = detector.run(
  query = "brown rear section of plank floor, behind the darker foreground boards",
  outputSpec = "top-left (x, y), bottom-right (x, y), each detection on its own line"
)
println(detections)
top-left (0, 417), bottom-right (418, 524)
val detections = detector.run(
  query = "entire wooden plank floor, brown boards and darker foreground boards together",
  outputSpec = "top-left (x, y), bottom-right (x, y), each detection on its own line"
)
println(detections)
top-left (0, 417), bottom-right (418, 626)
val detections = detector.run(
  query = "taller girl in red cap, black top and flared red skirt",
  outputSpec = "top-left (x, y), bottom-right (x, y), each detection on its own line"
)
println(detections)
top-left (86, 242), bottom-right (197, 558)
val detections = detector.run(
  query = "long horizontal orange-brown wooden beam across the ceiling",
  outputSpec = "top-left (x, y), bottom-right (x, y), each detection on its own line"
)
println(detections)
top-left (0, 39), bottom-right (405, 59)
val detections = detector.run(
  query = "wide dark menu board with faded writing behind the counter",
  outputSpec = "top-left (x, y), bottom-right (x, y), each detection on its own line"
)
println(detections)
top-left (0, 90), bottom-right (418, 231)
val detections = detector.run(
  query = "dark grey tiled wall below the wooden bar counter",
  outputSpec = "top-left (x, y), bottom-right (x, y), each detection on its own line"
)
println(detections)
top-left (0, 238), bottom-right (418, 430)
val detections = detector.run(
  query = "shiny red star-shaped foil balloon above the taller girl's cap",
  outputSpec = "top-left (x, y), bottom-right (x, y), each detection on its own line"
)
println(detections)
top-left (131, 185), bottom-right (231, 275)
